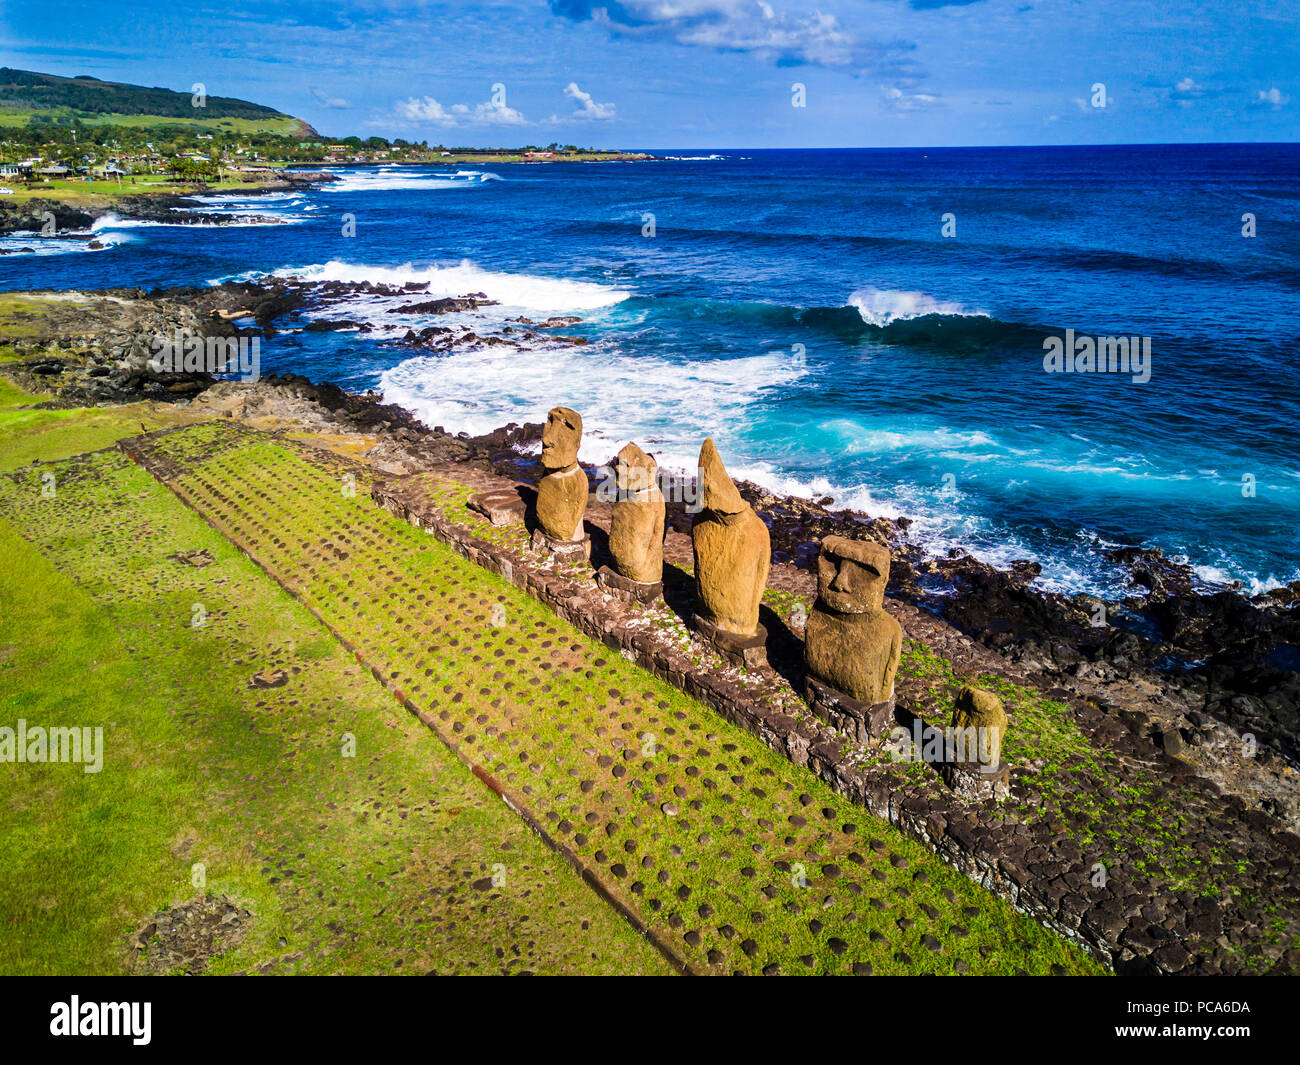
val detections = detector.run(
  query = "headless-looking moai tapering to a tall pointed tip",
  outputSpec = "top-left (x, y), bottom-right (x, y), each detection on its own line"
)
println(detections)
top-left (690, 440), bottom-right (772, 667)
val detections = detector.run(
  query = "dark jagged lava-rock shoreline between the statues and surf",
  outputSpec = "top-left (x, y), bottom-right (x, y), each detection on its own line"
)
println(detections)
top-left (3, 280), bottom-right (1300, 830)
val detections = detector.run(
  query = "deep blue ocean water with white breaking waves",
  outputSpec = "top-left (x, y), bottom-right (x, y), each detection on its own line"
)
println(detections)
top-left (0, 144), bottom-right (1300, 594)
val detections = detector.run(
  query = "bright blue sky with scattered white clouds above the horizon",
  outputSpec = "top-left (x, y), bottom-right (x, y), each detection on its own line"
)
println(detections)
top-left (0, 0), bottom-right (1300, 148)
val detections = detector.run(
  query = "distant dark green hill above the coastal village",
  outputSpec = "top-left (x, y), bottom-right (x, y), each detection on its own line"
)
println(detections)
top-left (0, 66), bottom-right (315, 137)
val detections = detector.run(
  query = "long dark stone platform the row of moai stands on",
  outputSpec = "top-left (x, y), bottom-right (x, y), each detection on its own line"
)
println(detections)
top-left (361, 468), bottom-right (1300, 973)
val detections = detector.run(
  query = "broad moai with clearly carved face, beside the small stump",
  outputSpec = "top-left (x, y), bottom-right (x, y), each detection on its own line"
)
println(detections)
top-left (803, 536), bottom-right (902, 743)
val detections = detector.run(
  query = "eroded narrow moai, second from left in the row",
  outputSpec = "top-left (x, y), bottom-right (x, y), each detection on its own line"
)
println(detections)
top-left (595, 443), bottom-right (664, 603)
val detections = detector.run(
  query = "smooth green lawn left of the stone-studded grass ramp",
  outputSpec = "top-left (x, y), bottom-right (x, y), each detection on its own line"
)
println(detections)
top-left (0, 451), bottom-right (667, 974)
